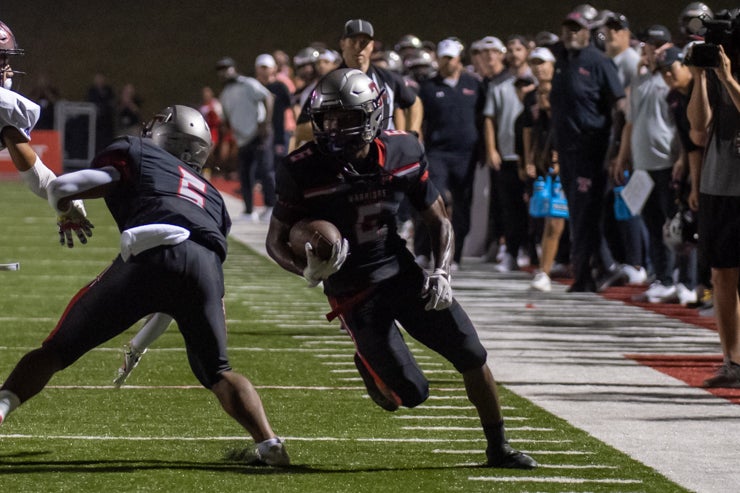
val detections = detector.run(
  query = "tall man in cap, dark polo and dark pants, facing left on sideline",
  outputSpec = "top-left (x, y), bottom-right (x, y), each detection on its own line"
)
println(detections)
top-left (550, 5), bottom-right (624, 292)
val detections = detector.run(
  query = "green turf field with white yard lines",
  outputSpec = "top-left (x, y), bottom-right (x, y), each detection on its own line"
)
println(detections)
top-left (0, 182), bottom-right (684, 493)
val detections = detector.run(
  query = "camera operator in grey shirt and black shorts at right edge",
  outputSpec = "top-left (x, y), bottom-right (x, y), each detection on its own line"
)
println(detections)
top-left (687, 9), bottom-right (740, 388)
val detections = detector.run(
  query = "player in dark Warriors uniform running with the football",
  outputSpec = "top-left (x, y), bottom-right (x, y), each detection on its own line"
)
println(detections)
top-left (266, 69), bottom-right (537, 469)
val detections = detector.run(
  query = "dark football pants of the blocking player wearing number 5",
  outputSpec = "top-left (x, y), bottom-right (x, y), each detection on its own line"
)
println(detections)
top-left (44, 241), bottom-right (231, 388)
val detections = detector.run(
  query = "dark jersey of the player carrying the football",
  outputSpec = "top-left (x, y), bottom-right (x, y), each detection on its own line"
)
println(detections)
top-left (273, 130), bottom-right (439, 296)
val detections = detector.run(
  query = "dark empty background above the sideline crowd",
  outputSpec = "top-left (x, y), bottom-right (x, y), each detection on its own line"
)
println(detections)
top-left (0, 0), bottom-right (733, 116)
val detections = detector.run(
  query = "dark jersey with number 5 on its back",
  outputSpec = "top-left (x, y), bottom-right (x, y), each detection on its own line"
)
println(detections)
top-left (92, 137), bottom-right (231, 261)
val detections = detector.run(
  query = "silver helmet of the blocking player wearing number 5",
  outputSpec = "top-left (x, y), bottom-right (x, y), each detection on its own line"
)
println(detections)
top-left (141, 104), bottom-right (211, 173)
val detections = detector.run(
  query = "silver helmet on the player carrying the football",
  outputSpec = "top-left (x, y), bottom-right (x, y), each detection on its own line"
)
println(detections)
top-left (310, 68), bottom-right (385, 155)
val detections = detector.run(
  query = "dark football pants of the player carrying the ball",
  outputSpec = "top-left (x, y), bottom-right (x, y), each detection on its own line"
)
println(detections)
top-left (331, 267), bottom-right (487, 407)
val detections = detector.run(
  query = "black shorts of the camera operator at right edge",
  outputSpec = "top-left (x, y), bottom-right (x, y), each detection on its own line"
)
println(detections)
top-left (698, 194), bottom-right (740, 269)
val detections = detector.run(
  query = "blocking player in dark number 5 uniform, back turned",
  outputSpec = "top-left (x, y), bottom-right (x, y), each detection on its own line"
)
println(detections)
top-left (0, 106), bottom-right (290, 466)
